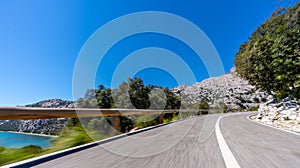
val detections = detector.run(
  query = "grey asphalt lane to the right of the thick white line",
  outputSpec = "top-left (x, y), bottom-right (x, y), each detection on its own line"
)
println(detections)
top-left (220, 113), bottom-right (300, 168)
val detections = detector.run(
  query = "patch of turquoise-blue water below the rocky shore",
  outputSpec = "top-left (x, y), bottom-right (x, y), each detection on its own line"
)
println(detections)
top-left (0, 132), bottom-right (54, 148)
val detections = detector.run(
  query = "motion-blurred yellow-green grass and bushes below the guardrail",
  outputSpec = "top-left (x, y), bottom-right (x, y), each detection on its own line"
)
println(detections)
top-left (0, 119), bottom-right (112, 166)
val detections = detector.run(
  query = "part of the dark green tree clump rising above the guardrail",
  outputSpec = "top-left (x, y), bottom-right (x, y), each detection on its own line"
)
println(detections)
top-left (77, 78), bottom-right (181, 109)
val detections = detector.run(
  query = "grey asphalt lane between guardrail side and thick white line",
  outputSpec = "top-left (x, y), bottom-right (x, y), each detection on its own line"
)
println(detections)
top-left (31, 115), bottom-right (225, 168)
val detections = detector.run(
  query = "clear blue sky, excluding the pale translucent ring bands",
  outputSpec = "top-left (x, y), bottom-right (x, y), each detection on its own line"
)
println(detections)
top-left (0, 0), bottom-right (295, 106)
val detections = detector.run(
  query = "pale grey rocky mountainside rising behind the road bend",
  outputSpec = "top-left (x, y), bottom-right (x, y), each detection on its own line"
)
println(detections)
top-left (172, 67), bottom-right (273, 110)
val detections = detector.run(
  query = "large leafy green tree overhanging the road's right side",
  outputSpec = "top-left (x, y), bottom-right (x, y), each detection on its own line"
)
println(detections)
top-left (235, 3), bottom-right (300, 99)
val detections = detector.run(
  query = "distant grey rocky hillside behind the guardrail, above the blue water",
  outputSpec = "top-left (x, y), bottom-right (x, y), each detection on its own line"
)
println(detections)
top-left (0, 99), bottom-right (75, 135)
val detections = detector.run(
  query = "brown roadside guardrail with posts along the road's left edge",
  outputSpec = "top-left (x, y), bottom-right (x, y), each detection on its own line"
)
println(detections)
top-left (0, 107), bottom-right (210, 130)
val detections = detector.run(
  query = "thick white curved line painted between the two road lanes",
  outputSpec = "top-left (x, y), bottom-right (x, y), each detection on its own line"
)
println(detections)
top-left (215, 116), bottom-right (240, 168)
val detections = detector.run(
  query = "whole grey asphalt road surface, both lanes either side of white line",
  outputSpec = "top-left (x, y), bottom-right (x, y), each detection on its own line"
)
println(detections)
top-left (14, 113), bottom-right (300, 168)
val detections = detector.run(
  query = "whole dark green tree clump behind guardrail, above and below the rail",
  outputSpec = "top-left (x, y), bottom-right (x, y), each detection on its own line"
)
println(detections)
top-left (77, 78), bottom-right (185, 135)
